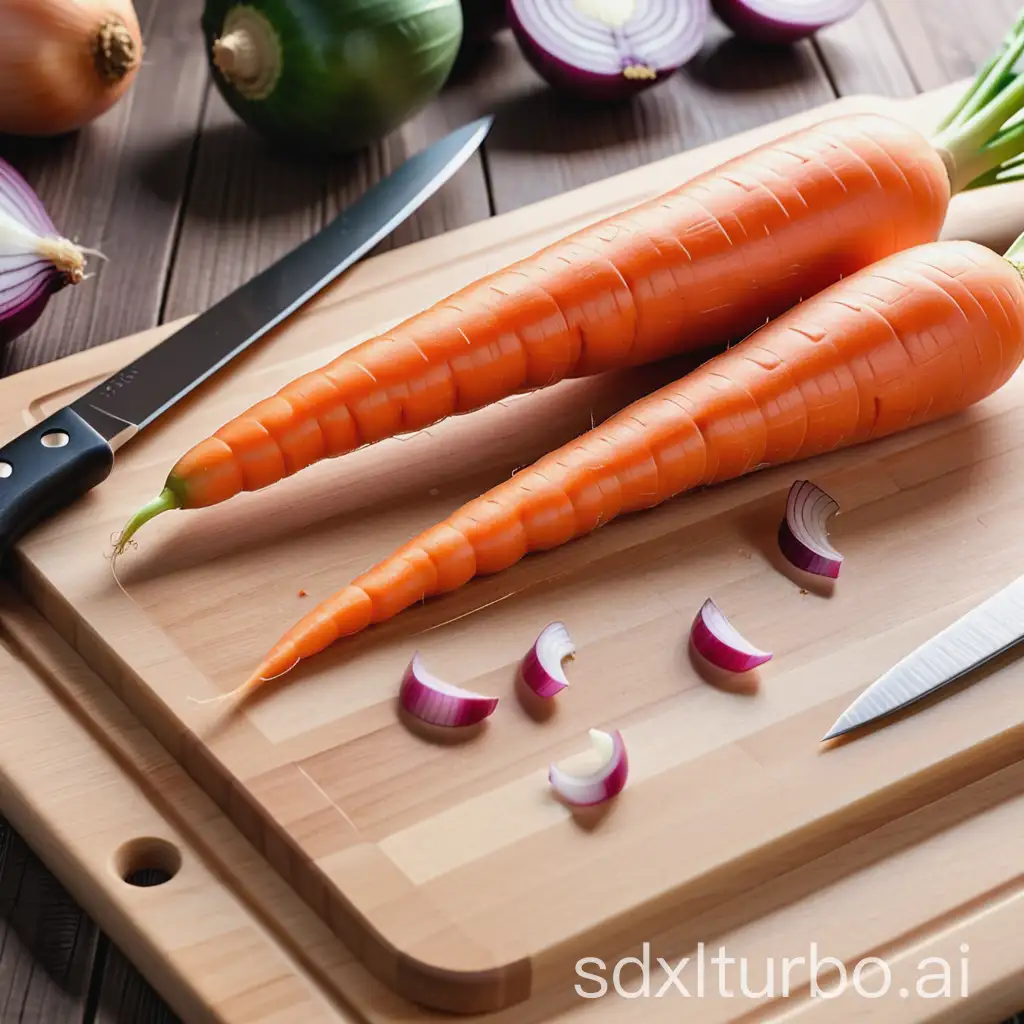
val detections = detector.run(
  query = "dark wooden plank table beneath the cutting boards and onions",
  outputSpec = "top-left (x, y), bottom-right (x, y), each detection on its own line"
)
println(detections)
top-left (0, 0), bottom-right (1024, 1024)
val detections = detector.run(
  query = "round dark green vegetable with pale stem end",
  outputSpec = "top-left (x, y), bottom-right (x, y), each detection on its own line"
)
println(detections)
top-left (203, 0), bottom-right (463, 153)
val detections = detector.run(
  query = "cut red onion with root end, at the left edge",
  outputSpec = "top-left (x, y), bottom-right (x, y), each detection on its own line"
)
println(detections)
top-left (0, 160), bottom-right (87, 342)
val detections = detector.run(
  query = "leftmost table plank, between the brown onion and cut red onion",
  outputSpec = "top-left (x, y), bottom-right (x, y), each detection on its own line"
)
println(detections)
top-left (0, 0), bottom-right (206, 373)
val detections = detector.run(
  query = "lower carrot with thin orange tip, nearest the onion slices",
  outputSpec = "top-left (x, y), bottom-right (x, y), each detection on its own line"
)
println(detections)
top-left (230, 236), bottom-right (1024, 690)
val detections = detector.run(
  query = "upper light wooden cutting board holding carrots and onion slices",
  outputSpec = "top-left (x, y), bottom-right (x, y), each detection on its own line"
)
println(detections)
top-left (0, 91), bottom-right (1024, 1024)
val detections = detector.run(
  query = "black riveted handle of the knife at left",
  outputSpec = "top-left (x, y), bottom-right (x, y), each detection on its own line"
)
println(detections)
top-left (0, 408), bottom-right (114, 560)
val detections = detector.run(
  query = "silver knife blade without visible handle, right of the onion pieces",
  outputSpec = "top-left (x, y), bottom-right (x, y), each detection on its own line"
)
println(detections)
top-left (821, 577), bottom-right (1024, 742)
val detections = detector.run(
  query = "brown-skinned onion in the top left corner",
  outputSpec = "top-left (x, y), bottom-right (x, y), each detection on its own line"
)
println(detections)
top-left (0, 0), bottom-right (143, 136)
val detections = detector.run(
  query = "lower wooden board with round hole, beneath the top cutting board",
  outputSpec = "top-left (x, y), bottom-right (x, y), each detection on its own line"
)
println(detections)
top-left (0, 552), bottom-right (1024, 1024)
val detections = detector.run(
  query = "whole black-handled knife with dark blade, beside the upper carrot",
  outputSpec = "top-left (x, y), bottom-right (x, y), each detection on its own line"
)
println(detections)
top-left (0, 117), bottom-right (493, 559)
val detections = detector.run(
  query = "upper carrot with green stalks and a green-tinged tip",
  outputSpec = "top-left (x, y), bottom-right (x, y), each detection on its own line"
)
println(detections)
top-left (118, 14), bottom-right (1024, 551)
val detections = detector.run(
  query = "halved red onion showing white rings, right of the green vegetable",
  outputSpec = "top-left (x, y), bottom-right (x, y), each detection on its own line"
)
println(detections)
top-left (508, 0), bottom-right (711, 99)
